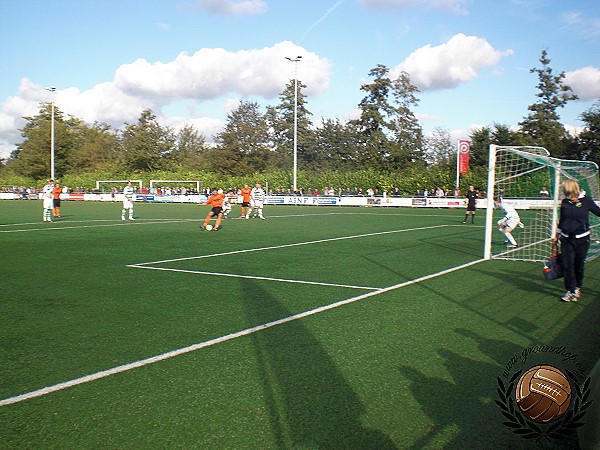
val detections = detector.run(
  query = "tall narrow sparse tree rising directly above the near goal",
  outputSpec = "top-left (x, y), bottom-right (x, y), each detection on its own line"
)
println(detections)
top-left (519, 49), bottom-right (578, 157)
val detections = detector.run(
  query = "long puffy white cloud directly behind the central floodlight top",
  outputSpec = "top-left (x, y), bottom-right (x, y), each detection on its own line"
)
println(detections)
top-left (115, 41), bottom-right (330, 100)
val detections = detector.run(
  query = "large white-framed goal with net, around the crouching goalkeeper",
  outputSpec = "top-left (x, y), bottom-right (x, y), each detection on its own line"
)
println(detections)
top-left (484, 145), bottom-right (600, 261)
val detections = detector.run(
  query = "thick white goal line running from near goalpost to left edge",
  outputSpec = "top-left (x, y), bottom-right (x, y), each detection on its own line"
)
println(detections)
top-left (0, 259), bottom-right (485, 407)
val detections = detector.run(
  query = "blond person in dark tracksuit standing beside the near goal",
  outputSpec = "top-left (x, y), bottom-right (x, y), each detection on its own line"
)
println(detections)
top-left (554, 180), bottom-right (600, 302)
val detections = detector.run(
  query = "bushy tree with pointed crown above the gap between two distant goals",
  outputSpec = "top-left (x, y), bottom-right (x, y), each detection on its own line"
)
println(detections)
top-left (121, 109), bottom-right (175, 171)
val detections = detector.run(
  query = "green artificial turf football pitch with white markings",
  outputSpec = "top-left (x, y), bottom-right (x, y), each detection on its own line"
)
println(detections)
top-left (0, 201), bottom-right (600, 449)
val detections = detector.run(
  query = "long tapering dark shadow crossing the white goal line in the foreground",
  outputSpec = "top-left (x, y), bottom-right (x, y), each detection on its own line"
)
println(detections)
top-left (242, 280), bottom-right (396, 449)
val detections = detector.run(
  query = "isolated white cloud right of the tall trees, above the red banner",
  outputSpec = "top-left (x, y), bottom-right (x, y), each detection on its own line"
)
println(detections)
top-left (390, 33), bottom-right (513, 90)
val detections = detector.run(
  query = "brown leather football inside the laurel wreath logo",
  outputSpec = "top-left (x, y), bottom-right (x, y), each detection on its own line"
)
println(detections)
top-left (515, 365), bottom-right (571, 423)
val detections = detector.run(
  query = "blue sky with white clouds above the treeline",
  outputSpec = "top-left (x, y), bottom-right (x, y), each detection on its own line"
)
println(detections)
top-left (0, 0), bottom-right (600, 157)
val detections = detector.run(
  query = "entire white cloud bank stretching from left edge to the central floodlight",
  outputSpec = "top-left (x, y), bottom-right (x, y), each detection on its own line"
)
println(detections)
top-left (0, 41), bottom-right (330, 157)
